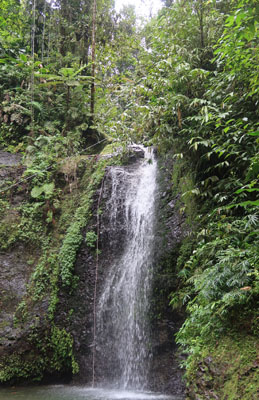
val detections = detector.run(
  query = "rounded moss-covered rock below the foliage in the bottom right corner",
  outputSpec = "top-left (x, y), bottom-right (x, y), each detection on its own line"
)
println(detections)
top-left (186, 334), bottom-right (259, 400)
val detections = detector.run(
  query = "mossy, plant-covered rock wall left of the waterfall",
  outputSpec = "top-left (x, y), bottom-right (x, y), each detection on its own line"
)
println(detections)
top-left (0, 148), bottom-right (127, 384)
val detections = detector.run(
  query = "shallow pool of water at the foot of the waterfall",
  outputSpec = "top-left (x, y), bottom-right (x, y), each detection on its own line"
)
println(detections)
top-left (0, 385), bottom-right (183, 400)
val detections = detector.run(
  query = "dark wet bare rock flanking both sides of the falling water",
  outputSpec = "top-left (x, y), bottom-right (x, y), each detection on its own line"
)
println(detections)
top-left (60, 148), bottom-right (187, 395)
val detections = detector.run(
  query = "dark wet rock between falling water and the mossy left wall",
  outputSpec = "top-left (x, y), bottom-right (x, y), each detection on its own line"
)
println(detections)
top-left (57, 162), bottom-right (143, 384)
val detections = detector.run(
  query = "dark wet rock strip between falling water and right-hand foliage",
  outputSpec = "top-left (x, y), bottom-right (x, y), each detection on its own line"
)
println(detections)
top-left (150, 159), bottom-right (185, 396)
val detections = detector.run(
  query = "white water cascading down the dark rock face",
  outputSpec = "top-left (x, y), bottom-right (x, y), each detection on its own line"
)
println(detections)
top-left (97, 148), bottom-right (157, 389)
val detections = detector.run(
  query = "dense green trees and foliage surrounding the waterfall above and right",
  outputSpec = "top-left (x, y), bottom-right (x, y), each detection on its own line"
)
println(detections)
top-left (0, 0), bottom-right (259, 399)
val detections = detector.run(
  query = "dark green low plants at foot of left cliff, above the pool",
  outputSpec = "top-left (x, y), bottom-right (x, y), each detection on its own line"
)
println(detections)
top-left (0, 325), bottom-right (78, 383)
